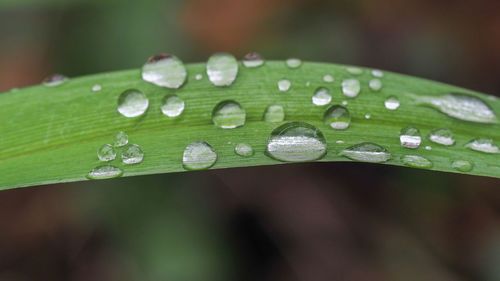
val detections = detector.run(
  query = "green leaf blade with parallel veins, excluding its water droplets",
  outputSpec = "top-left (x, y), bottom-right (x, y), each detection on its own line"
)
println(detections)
top-left (0, 61), bottom-right (500, 189)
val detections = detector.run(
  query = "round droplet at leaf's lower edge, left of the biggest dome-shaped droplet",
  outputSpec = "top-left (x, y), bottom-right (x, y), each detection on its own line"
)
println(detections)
top-left (182, 142), bottom-right (217, 170)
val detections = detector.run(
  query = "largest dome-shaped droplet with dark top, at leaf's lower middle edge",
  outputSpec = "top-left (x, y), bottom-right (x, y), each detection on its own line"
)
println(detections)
top-left (266, 122), bottom-right (327, 162)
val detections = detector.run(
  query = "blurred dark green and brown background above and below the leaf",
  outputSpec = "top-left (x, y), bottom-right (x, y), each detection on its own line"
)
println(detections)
top-left (0, 0), bottom-right (500, 281)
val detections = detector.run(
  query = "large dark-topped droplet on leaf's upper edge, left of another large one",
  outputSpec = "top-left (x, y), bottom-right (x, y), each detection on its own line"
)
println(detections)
top-left (142, 54), bottom-right (187, 89)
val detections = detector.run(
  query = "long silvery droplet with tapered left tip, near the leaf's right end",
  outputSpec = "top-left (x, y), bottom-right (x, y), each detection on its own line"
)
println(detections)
top-left (409, 93), bottom-right (498, 123)
